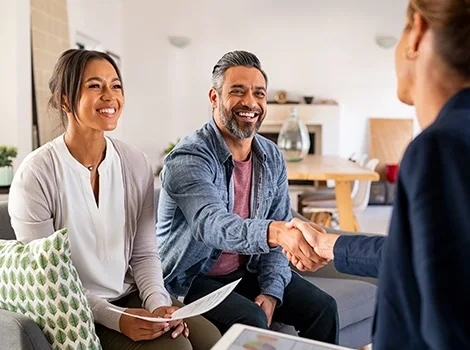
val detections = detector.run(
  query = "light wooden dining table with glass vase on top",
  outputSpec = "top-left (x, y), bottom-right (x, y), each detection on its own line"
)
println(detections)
top-left (286, 155), bottom-right (379, 232)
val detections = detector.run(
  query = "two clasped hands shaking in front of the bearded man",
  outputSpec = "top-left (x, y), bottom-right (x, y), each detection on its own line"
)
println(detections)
top-left (268, 219), bottom-right (339, 271)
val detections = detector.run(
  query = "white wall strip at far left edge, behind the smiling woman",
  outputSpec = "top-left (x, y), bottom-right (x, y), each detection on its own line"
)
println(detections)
top-left (0, 0), bottom-right (32, 167)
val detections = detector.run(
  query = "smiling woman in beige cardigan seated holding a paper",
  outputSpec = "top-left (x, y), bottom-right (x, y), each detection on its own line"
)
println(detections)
top-left (8, 49), bottom-right (220, 350)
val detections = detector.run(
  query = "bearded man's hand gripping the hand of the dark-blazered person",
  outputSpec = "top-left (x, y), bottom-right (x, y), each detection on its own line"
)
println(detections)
top-left (268, 221), bottom-right (328, 271)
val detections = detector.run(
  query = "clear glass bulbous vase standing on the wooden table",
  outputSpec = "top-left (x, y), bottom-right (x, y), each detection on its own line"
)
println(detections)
top-left (277, 108), bottom-right (310, 162)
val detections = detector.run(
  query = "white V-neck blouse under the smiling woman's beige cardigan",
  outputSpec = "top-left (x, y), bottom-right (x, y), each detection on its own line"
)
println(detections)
top-left (52, 135), bottom-right (130, 299)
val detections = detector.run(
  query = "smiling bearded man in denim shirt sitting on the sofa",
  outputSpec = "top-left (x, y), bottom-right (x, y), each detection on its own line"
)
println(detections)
top-left (157, 51), bottom-right (338, 344)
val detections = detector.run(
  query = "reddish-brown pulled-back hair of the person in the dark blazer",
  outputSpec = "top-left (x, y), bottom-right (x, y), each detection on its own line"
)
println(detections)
top-left (407, 0), bottom-right (470, 78)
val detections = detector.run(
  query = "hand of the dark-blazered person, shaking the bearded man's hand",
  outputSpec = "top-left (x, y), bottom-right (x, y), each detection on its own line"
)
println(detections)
top-left (284, 219), bottom-right (339, 271)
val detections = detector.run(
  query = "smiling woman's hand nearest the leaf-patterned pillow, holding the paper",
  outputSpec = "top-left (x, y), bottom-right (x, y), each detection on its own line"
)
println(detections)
top-left (119, 309), bottom-right (170, 341)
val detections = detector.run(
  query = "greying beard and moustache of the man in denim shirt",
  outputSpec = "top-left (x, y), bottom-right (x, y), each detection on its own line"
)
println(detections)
top-left (219, 103), bottom-right (264, 140)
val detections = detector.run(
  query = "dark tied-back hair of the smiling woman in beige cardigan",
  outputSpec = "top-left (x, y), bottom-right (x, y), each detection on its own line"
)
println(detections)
top-left (48, 49), bottom-right (124, 128)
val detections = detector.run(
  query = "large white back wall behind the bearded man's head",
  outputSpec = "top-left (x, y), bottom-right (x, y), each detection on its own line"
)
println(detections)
top-left (122, 0), bottom-right (413, 169)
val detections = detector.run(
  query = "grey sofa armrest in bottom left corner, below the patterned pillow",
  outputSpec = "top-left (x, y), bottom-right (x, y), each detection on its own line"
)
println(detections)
top-left (0, 310), bottom-right (51, 350)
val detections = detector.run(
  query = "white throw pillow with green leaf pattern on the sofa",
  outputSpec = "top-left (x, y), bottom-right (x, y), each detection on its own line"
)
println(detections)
top-left (0, 229), bottom-right (101, 350)
